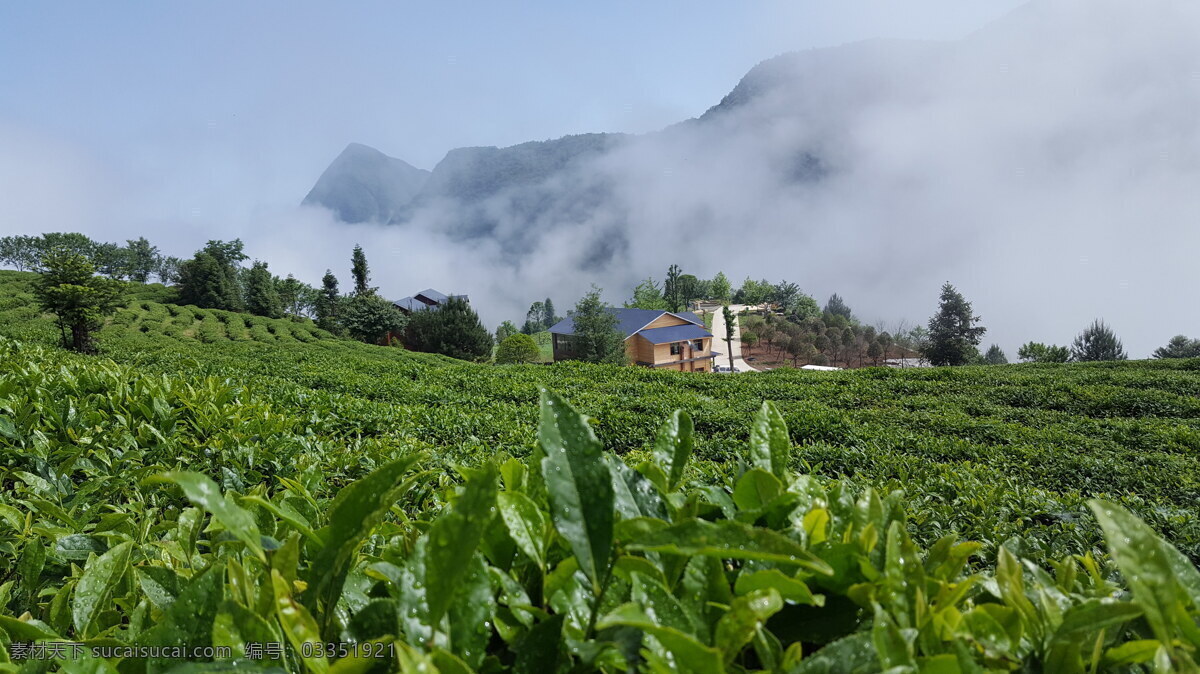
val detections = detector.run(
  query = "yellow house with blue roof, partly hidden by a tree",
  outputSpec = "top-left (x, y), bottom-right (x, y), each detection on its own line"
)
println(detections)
top-left (550, 308), bottom-right (721, 372)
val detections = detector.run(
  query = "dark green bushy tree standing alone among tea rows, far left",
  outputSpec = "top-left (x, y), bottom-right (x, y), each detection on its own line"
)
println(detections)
top-left (34, 248), bottom-right (122, 354)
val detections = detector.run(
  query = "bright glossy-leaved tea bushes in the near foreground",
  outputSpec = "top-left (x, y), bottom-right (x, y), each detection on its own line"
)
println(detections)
top-left (0, 339), bottom-right (1200, 673)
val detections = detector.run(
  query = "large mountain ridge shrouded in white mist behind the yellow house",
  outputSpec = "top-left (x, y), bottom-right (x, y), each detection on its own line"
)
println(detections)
top-left (297, 0), bottom-right (1200, 354)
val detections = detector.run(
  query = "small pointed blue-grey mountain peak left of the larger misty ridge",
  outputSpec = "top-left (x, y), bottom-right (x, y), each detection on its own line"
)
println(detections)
top-left (304, 143), bottom-right (430, 223)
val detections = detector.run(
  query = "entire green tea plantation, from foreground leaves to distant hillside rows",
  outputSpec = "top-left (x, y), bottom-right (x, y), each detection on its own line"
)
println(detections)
top-left (7, 272), bottom-right (1200, 672)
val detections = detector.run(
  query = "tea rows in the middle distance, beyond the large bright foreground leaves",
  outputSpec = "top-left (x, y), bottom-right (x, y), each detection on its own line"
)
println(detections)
top-left (0, 272), bottom-right (1200, 559)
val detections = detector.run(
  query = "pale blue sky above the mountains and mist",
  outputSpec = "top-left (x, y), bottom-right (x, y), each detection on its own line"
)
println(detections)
top-left (0, 0), bottom-right (1019, 207)
